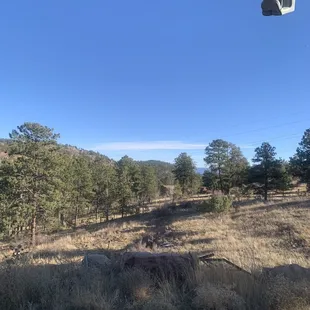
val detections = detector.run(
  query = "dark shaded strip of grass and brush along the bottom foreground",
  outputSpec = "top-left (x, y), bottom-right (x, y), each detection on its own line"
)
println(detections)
top-left (0, 251), bottom-right (310, 310)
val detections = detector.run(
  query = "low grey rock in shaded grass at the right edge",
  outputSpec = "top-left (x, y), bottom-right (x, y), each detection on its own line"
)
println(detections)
top-left (263, 264), bottom-right (310, 281)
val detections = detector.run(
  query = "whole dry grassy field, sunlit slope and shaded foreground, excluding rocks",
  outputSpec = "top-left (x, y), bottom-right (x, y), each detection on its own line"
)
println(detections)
top-left (0, 198), bottom-right (310, 309)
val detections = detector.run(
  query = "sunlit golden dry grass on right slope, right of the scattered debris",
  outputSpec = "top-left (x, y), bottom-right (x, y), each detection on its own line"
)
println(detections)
top-left (172, 200), bottom-right (310, 269)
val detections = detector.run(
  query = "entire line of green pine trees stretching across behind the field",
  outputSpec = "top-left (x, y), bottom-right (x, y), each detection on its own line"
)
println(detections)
top-left (0, 122), bottom-right (310, 244)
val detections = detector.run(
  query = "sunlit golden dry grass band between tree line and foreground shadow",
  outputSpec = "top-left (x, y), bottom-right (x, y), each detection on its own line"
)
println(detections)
top-left (2, 199), bottom-right (310, 269)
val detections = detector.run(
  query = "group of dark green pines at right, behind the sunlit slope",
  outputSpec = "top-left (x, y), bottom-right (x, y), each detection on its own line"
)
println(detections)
top-left (203, 134), bottom-right (310, 200)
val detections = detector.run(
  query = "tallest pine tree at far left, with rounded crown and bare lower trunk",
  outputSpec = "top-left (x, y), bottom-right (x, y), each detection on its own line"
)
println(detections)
top-left (4, 123), bottom-right (59, 245)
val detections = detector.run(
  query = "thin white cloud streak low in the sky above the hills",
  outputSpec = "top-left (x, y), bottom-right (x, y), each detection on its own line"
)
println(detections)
top-left (93, 141), bottom-right (253, 151)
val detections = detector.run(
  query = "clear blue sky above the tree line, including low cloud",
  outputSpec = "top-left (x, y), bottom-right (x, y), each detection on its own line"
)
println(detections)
top-left (0, 0), bottom-right (310, 166)
